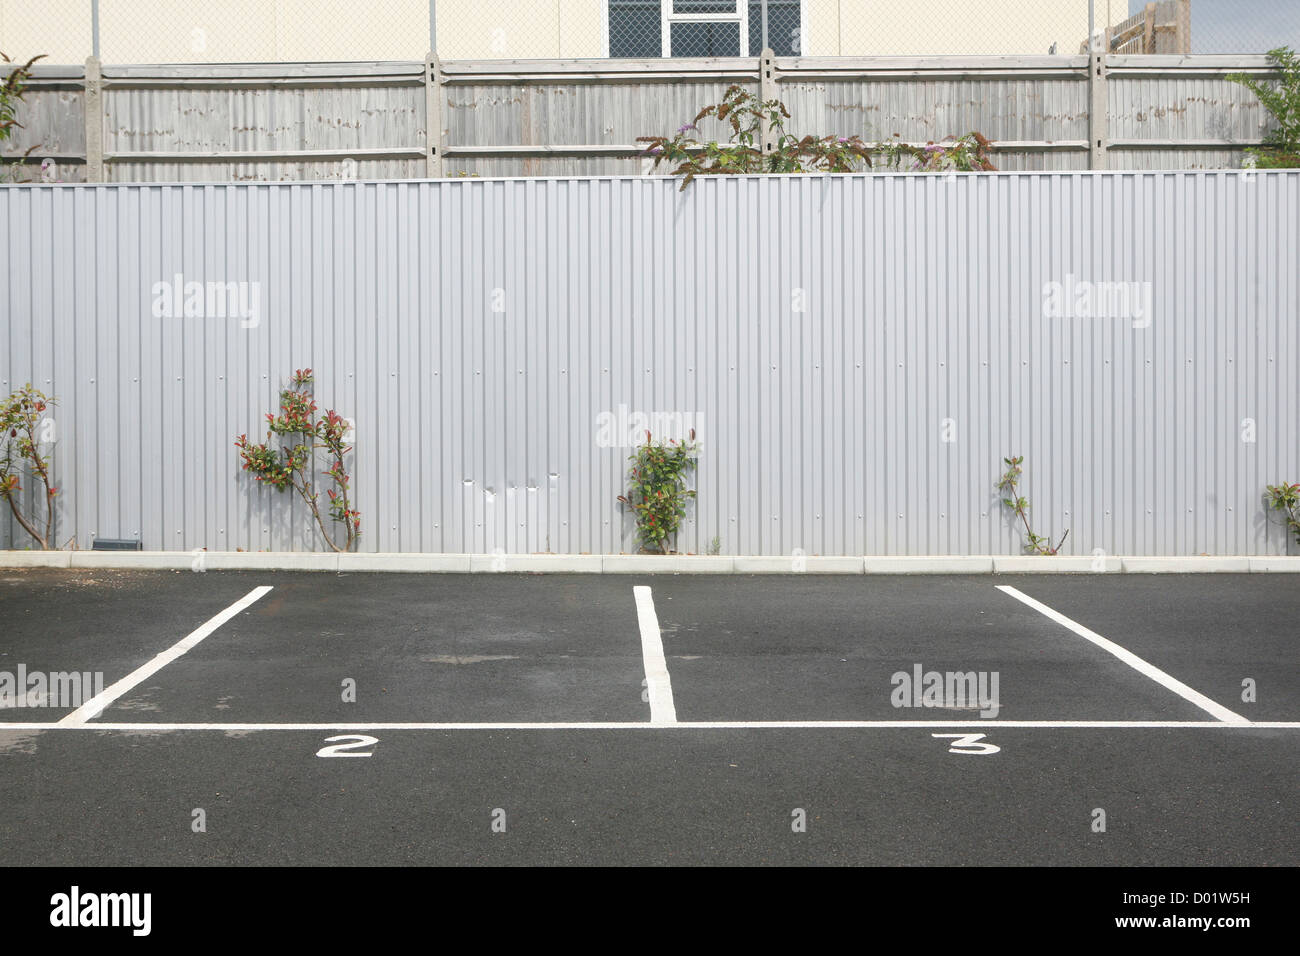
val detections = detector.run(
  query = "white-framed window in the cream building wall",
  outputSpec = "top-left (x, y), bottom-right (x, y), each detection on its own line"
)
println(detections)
top-left (608, 0), bottom-right (802, 57)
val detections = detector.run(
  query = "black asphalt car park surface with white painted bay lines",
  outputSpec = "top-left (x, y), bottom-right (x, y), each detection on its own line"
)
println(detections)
top-left (0, 570), bottom-right (1300, 866)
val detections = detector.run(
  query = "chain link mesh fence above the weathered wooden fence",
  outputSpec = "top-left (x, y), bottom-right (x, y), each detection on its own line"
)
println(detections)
top-left (0, 0), bottom-right (1300, 64)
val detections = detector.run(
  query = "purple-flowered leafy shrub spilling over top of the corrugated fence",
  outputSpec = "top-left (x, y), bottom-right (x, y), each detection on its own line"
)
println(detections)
top-left (637, 86), bottom-right (995, 189)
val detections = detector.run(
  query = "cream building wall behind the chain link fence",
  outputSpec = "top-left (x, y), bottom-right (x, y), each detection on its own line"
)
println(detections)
top-left (0, 0), bottom-right (1097, 64)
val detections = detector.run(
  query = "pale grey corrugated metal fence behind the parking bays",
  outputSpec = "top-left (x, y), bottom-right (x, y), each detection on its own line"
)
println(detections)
top-left (0, 172), bottom-right (1300, 554)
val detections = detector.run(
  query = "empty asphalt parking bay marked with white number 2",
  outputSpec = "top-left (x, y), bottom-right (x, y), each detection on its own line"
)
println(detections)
top-left (92, 572), bottom-right (650, 723)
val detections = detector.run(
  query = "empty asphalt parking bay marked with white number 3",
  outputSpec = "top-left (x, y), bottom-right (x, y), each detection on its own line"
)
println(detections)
top-left (657, 576), bottom-right (1208, 721)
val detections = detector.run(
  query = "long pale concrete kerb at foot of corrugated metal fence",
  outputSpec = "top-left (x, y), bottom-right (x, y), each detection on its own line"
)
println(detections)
top-left (0, 550), bottom-right (1300, 575)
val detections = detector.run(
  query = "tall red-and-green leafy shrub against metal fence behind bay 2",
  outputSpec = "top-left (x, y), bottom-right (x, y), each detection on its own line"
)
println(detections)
top-left (235, 368), bottom-right (361, 551)
